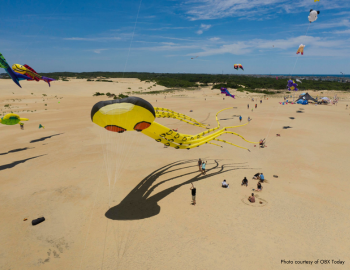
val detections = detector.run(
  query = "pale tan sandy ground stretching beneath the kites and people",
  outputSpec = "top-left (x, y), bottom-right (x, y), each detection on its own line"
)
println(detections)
top-left (0, 79), bottom-right (350, 269)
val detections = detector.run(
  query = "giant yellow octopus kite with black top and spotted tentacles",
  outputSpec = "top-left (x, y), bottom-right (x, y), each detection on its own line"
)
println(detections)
top-left (91, 97), bottom-right (257, 150)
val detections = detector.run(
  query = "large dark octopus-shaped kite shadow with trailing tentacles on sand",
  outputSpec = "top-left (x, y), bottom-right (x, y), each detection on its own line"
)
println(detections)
top-left (105, 160), bottom-right (253, 220)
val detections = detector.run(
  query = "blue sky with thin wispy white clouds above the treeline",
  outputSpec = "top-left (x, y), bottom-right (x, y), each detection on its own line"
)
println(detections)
top-left (0, 0), bottom-right (350, 75)
